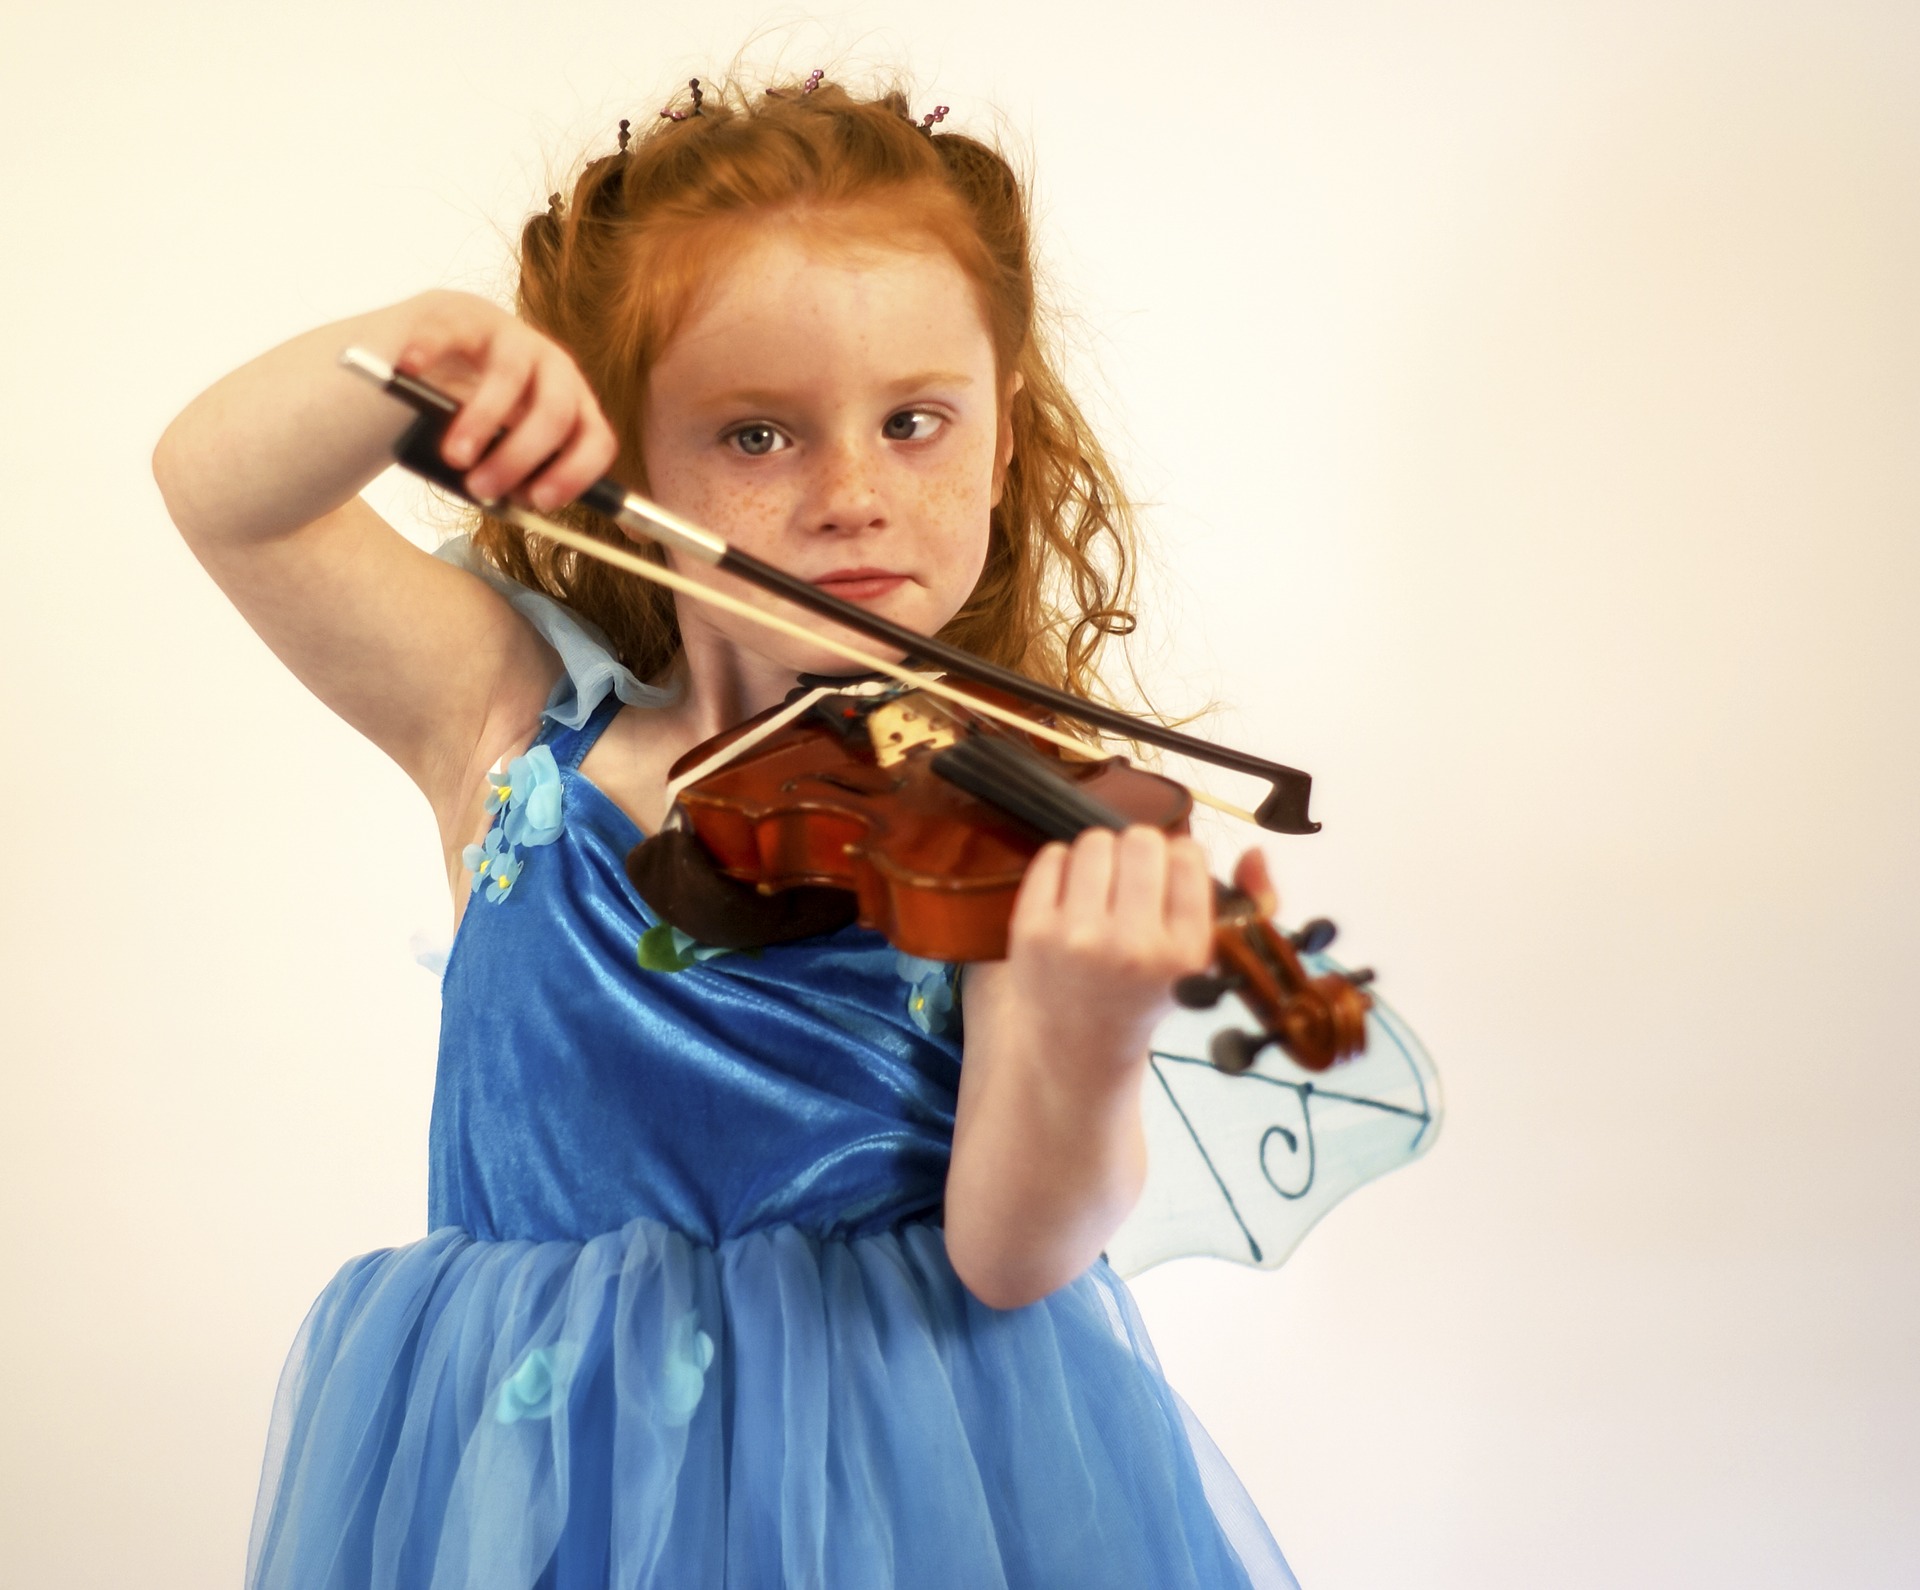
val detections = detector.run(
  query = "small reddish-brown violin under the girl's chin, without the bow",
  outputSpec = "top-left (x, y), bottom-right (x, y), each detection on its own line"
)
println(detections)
top-left (626, 678), bottom-right (1373, 1072)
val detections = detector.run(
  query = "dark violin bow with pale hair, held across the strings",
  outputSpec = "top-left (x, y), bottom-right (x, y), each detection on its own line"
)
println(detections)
top-left (340, 348), bottom-right (1319, 833)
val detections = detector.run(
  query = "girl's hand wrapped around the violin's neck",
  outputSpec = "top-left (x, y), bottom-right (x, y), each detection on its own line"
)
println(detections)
top-left (1006, 826), bottom-right (1213, 1079)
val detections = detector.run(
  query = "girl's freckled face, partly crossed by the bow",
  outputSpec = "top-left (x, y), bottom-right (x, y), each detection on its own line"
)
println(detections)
top-left (641, 227), bottom-right (1008, 674)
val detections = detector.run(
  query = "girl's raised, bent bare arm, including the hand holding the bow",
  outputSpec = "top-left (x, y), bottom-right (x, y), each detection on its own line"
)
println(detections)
top-left (154, 292), bottom-right (614, 843)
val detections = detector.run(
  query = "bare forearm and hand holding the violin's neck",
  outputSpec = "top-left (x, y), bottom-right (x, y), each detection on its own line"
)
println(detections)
top-left (947, 828), bottom-right (1213, 1308)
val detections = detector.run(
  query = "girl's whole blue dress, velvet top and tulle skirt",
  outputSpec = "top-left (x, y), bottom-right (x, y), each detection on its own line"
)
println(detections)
top-left (248, 556), bottom-right (1294, 1590)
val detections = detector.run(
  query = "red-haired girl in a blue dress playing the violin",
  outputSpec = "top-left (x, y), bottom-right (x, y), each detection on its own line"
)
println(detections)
top-left (156, 73), bottom-right (1294, 1590)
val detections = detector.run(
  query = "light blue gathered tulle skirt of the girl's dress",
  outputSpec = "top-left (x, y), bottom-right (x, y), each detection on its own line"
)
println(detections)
top-left (248, 1219), bottom-right (1294, 1590)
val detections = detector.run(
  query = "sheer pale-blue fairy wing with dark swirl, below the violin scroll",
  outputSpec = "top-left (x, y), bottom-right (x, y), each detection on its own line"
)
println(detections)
top-left (1106, 956), bottom-right (1440, 1275)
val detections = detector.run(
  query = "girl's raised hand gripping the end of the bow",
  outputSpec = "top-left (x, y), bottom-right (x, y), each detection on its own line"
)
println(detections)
top-left (394, 292), bottom-right (620, 511)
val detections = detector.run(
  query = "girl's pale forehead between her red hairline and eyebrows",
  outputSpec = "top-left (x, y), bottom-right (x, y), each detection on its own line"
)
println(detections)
top-left (653, 219), bottom-right (993, 386)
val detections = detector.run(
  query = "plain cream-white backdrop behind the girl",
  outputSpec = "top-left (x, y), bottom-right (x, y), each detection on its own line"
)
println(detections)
top-left (0, 0), bottom-right (1920, 1590)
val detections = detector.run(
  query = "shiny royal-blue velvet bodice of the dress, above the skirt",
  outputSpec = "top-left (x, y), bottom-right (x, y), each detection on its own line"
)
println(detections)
top-left (428, 695), bottom-right (960, 1244)
